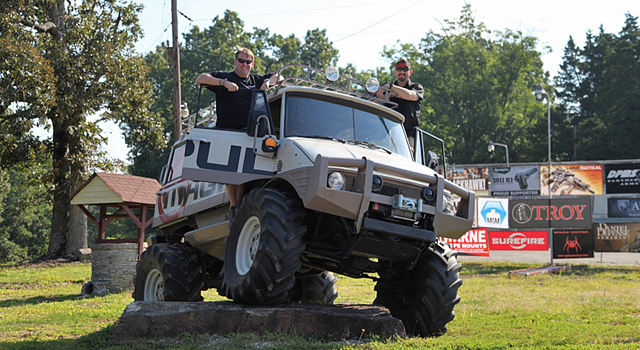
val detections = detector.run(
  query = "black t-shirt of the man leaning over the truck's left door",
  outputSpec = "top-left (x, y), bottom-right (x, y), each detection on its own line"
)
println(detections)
top-left (207, 71), bottom-right (272, 129)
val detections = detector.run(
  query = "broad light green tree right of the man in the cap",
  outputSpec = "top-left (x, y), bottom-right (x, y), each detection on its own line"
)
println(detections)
top-left (384, 4), bottom-right (547, 164)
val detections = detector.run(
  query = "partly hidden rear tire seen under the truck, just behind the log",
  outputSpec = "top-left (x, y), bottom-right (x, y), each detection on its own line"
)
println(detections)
top-left (287, 271), bottom-right (338, 305)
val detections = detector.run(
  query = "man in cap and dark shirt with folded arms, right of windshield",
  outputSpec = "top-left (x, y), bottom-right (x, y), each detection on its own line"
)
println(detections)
top-left (376, 59), bottom-right (424, 151)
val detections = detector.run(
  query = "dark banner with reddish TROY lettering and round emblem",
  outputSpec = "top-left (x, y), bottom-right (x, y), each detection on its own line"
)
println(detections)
top-left (509, 197), bottom-right (596, 229)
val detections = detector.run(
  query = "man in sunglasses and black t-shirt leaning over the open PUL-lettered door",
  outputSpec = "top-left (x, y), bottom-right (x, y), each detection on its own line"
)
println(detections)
top-left (196, 46), bottom-right (279, 217)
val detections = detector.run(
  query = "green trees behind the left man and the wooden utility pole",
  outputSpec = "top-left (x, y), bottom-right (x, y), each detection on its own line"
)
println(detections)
top-left (132, 10), bottom-right (342, 178)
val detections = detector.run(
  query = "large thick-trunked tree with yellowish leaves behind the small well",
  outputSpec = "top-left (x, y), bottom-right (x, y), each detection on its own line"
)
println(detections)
top-left (0, 0), bottom-right (155, 258)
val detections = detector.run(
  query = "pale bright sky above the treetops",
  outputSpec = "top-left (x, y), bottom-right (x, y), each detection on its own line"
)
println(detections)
top-left (105, 0), bottom-right (640, 160)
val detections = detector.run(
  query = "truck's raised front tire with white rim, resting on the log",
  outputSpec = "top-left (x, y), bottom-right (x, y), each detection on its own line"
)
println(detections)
top-left (222, 188), bottom-right (306, 305)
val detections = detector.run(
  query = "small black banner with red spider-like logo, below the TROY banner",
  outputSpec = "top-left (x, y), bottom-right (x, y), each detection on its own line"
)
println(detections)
top-left (553, 230), bottom-right (594, 259)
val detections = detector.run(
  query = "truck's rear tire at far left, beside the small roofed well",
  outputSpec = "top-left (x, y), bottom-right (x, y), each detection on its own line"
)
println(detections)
top-left (133, 243), bottom-right (203, 301)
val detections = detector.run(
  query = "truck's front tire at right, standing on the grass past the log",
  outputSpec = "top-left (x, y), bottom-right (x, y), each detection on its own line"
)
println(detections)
top-left (374, 243), bottom-right (462, 337)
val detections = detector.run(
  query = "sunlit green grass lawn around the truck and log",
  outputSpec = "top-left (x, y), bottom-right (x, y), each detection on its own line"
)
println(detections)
top-left (0, 262), bottom-right (640, 350)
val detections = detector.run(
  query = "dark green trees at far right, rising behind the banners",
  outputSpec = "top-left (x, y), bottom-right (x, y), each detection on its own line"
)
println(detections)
top-left (555, 14), bottom-right (640, 160)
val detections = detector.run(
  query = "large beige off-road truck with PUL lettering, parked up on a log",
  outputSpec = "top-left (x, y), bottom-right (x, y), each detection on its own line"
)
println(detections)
top-left (133, 65), bottom-right (474, 336)
